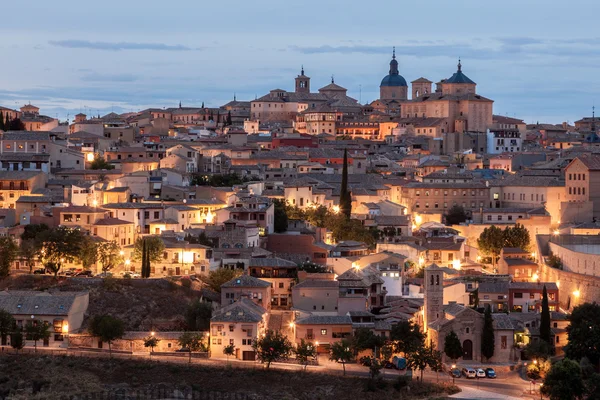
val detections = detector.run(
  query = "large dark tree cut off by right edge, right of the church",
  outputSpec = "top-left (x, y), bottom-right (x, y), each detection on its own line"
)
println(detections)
top-left (565, 303), bottom-right (600, 365)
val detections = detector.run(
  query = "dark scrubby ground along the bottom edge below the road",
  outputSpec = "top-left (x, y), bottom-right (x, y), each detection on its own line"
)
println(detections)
top-left (0, 355), bottom-right (454, 400)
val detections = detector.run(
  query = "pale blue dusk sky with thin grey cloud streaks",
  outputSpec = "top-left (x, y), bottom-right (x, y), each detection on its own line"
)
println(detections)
top-left (0, 0), bottom-right (600, 123)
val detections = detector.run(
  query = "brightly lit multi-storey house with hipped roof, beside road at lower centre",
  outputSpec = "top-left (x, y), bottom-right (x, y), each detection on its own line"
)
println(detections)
top-left (210, 297), bottom-right (269, 361)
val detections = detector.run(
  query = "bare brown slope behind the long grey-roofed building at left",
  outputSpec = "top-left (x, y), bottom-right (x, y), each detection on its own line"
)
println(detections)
top-left (0, 275), bottom-right (211, 331)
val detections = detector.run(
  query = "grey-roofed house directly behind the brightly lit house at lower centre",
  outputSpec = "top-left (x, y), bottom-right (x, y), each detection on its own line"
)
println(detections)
top-left (221, 275), bottom-right (271, 310)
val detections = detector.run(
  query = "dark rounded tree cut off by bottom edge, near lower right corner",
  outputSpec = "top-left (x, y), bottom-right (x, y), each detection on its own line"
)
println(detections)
top-left (541, 358), bottom-right (585, 400)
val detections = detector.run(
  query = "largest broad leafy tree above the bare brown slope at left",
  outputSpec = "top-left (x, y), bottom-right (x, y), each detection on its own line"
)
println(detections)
top-left (39, 226), bottom-right (85, 278)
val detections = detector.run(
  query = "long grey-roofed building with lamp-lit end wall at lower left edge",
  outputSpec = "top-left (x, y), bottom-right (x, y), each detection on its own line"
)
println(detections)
top-left (0, 290), bottom-right (89, 347)
